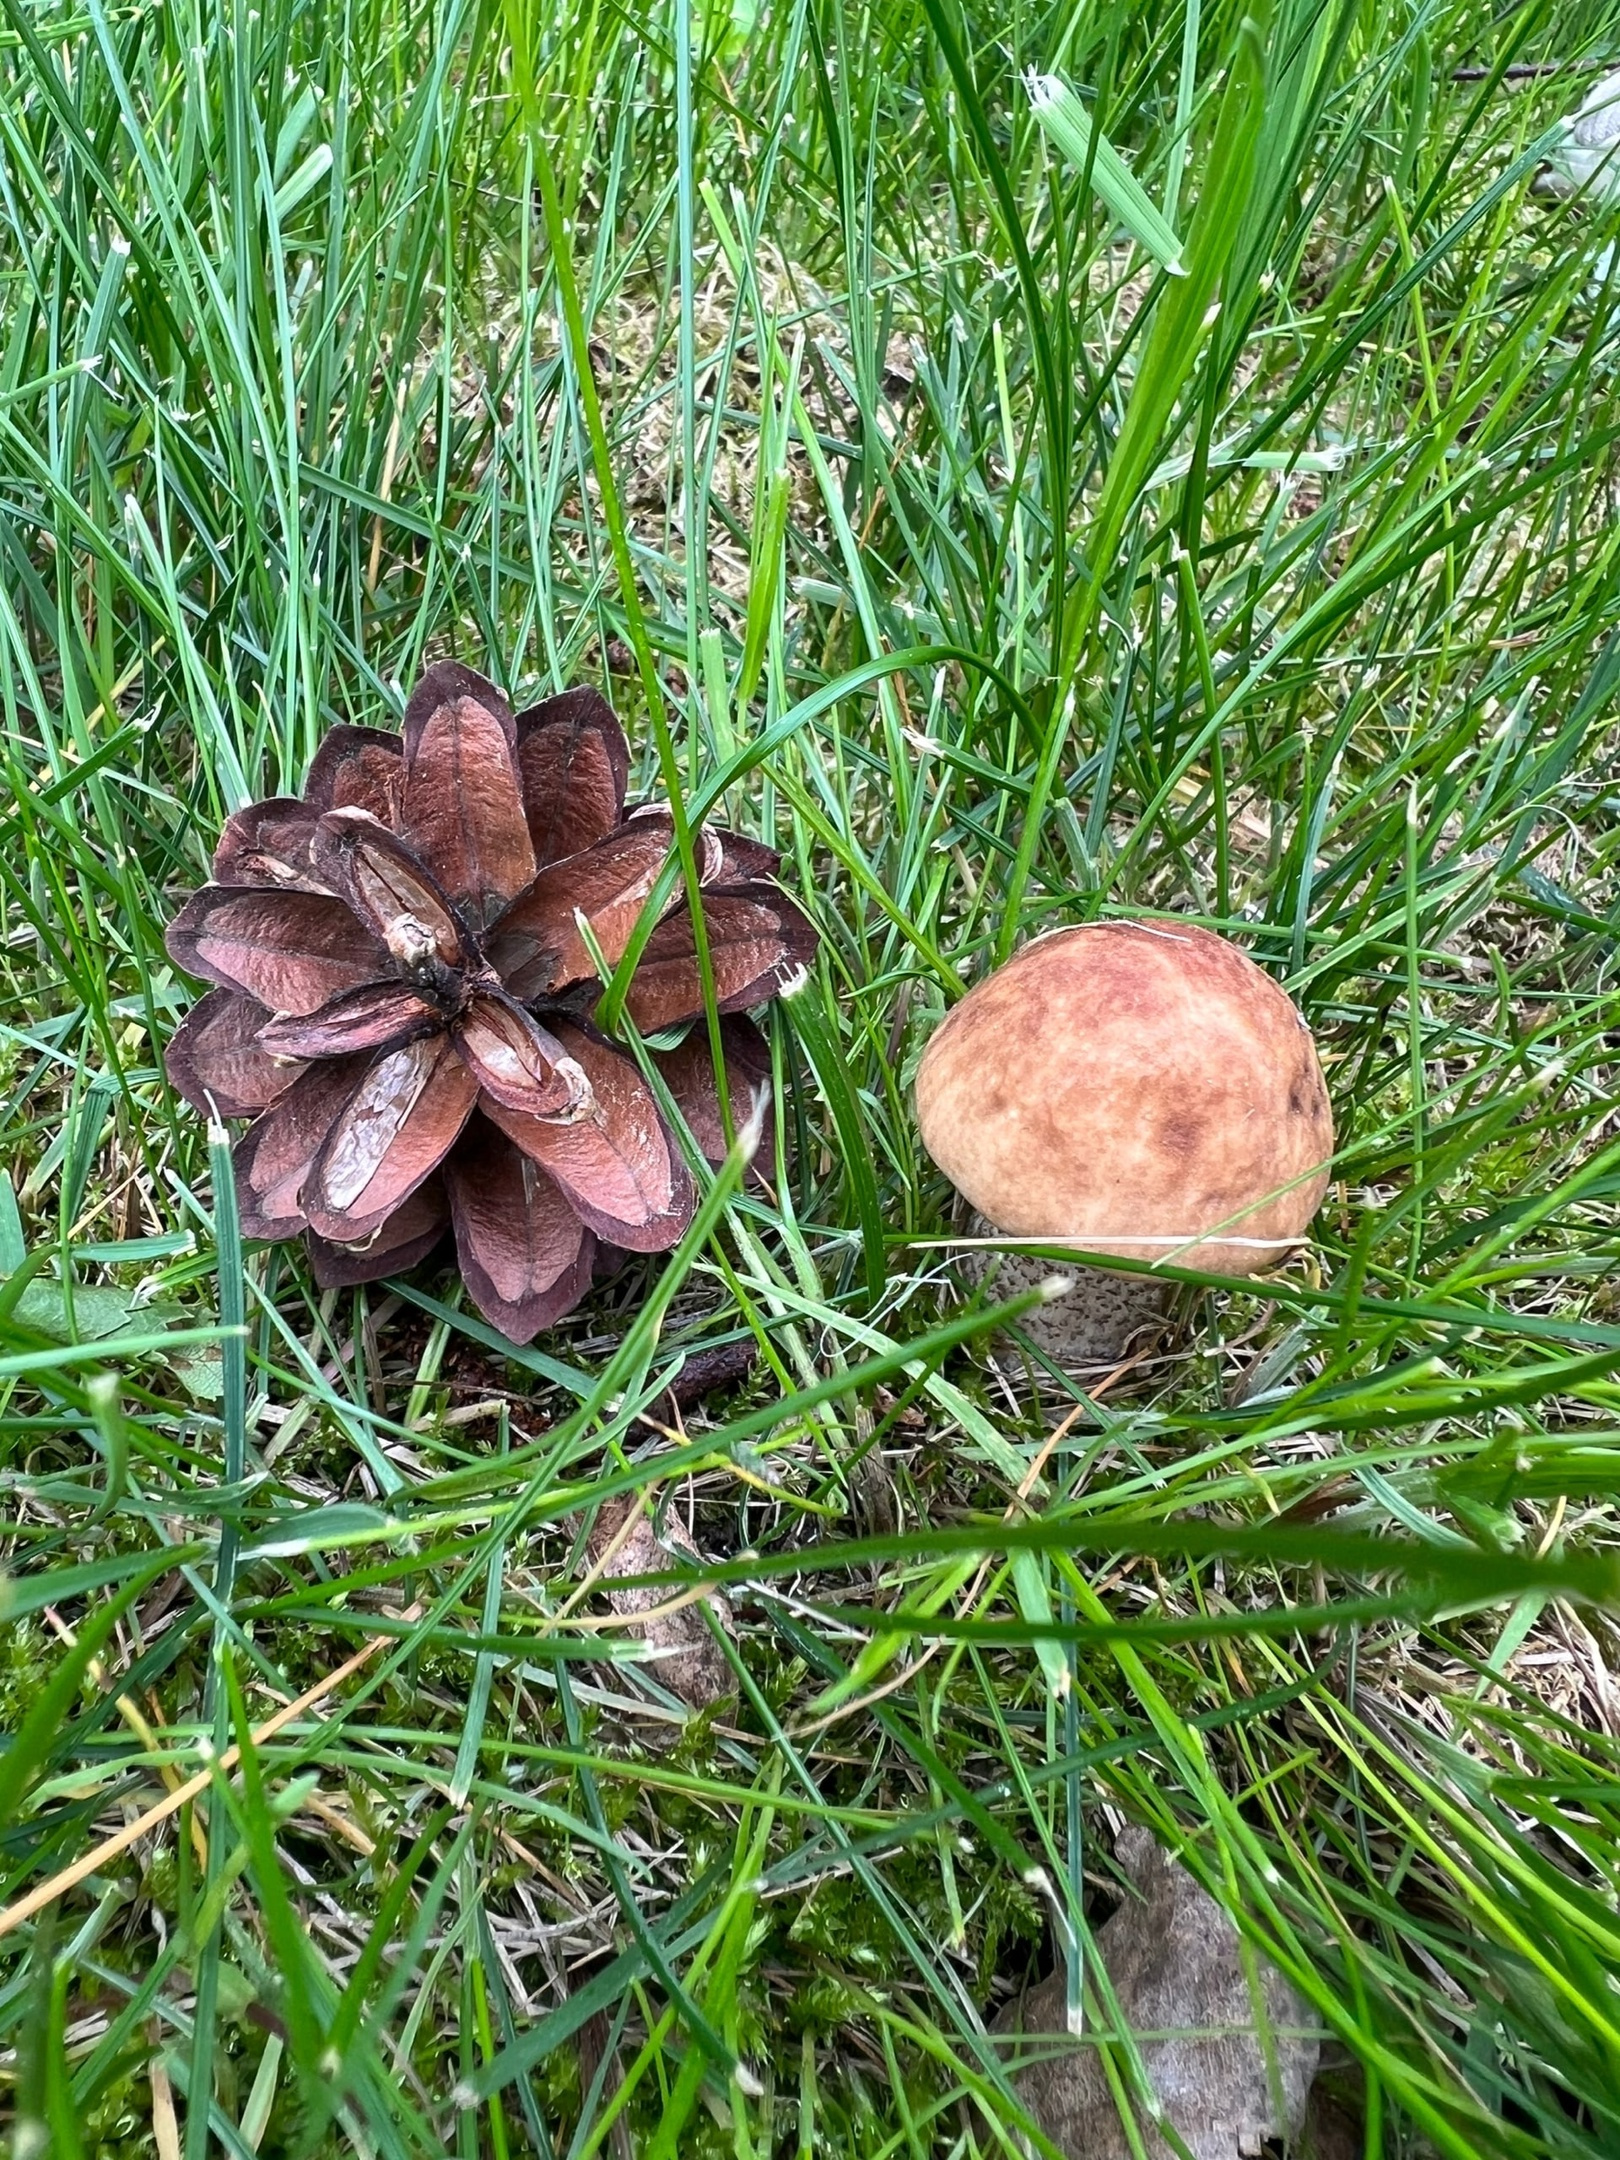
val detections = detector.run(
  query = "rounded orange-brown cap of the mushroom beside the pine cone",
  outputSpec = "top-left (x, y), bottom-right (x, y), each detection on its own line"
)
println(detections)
top-left (916, 922), bottom-right (1333, 1274)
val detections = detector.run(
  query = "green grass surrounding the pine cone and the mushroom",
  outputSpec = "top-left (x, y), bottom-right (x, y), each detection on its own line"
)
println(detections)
top-left (0, 0), bottom-right (1620, 2160)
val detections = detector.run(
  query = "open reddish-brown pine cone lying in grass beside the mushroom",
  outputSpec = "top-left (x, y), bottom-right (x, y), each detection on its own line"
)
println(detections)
top-left (168, 663), bottom-right (816, 1341)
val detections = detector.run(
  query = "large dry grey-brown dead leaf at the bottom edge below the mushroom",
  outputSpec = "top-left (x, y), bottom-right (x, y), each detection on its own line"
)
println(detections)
top-left (996, 1827), bottom-right (1320, 2160)
